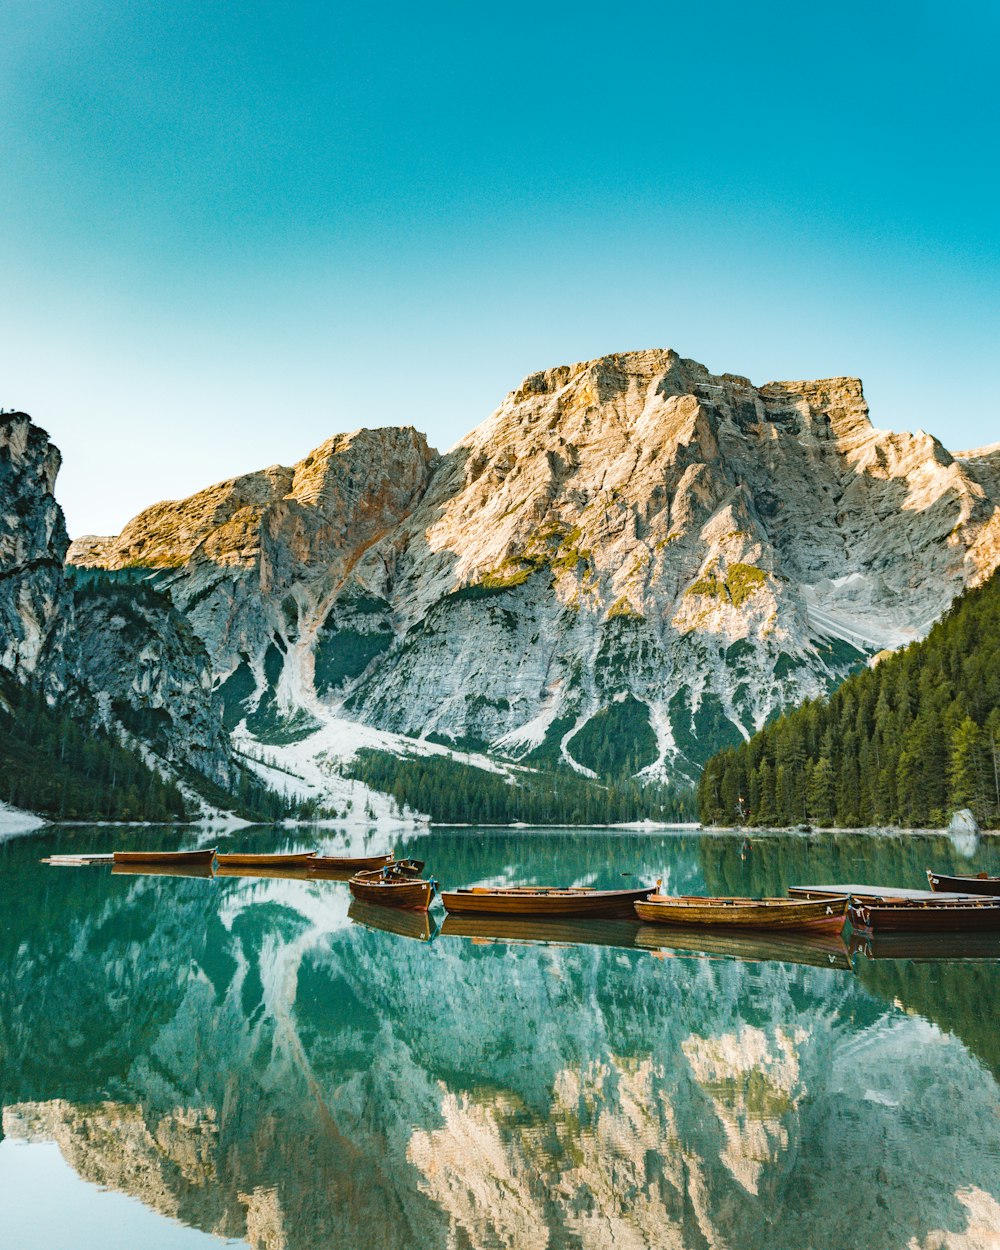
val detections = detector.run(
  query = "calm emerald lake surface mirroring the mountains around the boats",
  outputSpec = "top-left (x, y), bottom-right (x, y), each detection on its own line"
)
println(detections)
top-left (0, 829), bottom-right (1000, 1250)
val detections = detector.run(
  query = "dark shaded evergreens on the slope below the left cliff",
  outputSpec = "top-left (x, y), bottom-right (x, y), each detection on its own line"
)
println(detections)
top-left (0, 675), bottom-right (189, 821)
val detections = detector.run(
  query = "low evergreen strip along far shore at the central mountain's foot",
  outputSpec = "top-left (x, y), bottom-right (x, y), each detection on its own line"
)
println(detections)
top-left (348, 750), bottom-right (695, 825)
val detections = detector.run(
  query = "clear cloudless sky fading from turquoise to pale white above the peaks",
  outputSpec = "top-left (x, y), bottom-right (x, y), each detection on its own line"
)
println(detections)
top-left (0, 0), bottom-right (1000, 535)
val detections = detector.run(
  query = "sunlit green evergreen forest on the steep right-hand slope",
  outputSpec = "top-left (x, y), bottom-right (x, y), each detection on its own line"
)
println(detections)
top-left (699, 574), bottom-right (1000, 828)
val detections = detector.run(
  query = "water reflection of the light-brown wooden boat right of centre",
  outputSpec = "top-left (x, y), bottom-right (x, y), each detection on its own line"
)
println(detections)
top-left (635, 925), bottom-right (851, 971)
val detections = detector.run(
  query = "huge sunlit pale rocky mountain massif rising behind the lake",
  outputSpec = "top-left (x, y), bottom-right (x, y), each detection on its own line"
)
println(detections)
top-left (69, 350), bottom-right (1000, 795)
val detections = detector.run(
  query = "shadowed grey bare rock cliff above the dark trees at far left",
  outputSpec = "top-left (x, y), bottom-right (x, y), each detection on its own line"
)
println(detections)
top-left (0, 413), bottom-right (235, 786)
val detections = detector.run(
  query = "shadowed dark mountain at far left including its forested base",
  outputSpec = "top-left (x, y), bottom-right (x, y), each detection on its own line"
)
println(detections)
top-left (0, 413), bottom-right (259, 819)
